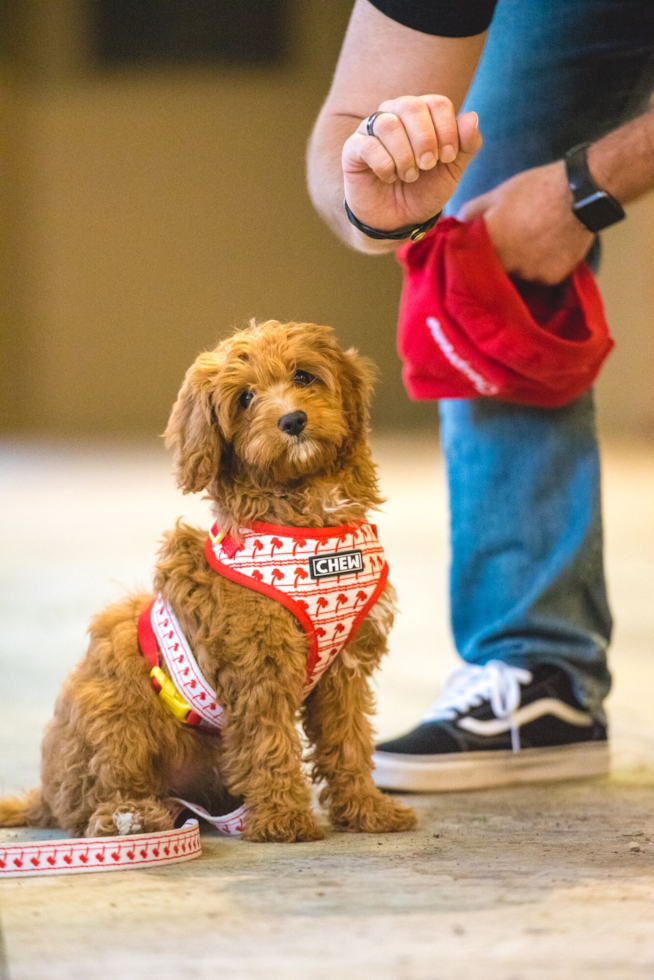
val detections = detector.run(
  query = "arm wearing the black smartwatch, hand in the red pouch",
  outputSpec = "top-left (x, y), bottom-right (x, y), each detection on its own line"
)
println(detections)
top-left (458, 108), bottom-right (654, 285)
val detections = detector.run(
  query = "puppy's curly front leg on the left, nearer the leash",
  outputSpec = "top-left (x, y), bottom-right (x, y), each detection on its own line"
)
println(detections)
top-left (221, 657), bottom-right (324, 842)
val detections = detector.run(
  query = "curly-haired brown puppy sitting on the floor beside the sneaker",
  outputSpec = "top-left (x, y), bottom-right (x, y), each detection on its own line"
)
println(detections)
top-left (0, 320), bottom-right (415, 841)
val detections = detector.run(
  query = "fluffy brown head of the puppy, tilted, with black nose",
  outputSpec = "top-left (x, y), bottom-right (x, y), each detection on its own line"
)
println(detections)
top-left (166, 320), bottom-right (374, 493)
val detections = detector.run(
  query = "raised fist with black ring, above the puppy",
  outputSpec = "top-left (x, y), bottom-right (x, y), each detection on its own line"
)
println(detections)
top-left (342, 95), bottom-right (481, 231)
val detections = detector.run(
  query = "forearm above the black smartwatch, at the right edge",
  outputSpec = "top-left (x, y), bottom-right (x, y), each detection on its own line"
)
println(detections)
top-left (588, 106), bottom-right (654, 204)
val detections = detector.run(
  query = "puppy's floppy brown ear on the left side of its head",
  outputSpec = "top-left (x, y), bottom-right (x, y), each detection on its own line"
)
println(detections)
top-left (164, 351), bottom-right (224, 493)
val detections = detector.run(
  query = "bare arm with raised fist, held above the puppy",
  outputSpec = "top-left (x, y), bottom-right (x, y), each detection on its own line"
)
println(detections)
top-left (308, 0), bottom-right (485, 252)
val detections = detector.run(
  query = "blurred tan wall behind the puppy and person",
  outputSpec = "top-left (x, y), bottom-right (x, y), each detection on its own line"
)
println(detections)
top-left (0, 0), bottom-right (654, 436)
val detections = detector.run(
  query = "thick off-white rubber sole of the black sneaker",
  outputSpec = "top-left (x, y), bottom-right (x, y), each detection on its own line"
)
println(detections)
top-left (372, 742), bottom-right (611, 793)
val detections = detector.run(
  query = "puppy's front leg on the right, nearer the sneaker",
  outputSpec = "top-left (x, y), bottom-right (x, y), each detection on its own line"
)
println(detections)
top-left (304, 604), bottom-right (416, 833)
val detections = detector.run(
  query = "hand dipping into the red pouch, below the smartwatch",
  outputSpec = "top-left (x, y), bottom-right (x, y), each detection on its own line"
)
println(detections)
top-left (457, 160), bottom-right (593, 286)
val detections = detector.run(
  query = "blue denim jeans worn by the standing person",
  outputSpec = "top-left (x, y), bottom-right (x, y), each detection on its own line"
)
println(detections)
top-left (440, 0), bottom-right (654, 718)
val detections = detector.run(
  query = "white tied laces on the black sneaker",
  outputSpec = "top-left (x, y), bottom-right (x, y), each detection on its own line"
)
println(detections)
top-left (422, 660), bottom-right (533, 752)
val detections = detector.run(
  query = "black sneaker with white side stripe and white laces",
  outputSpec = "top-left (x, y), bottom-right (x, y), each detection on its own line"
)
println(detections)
top-left (373, 660), bottom-right (609, 792)
